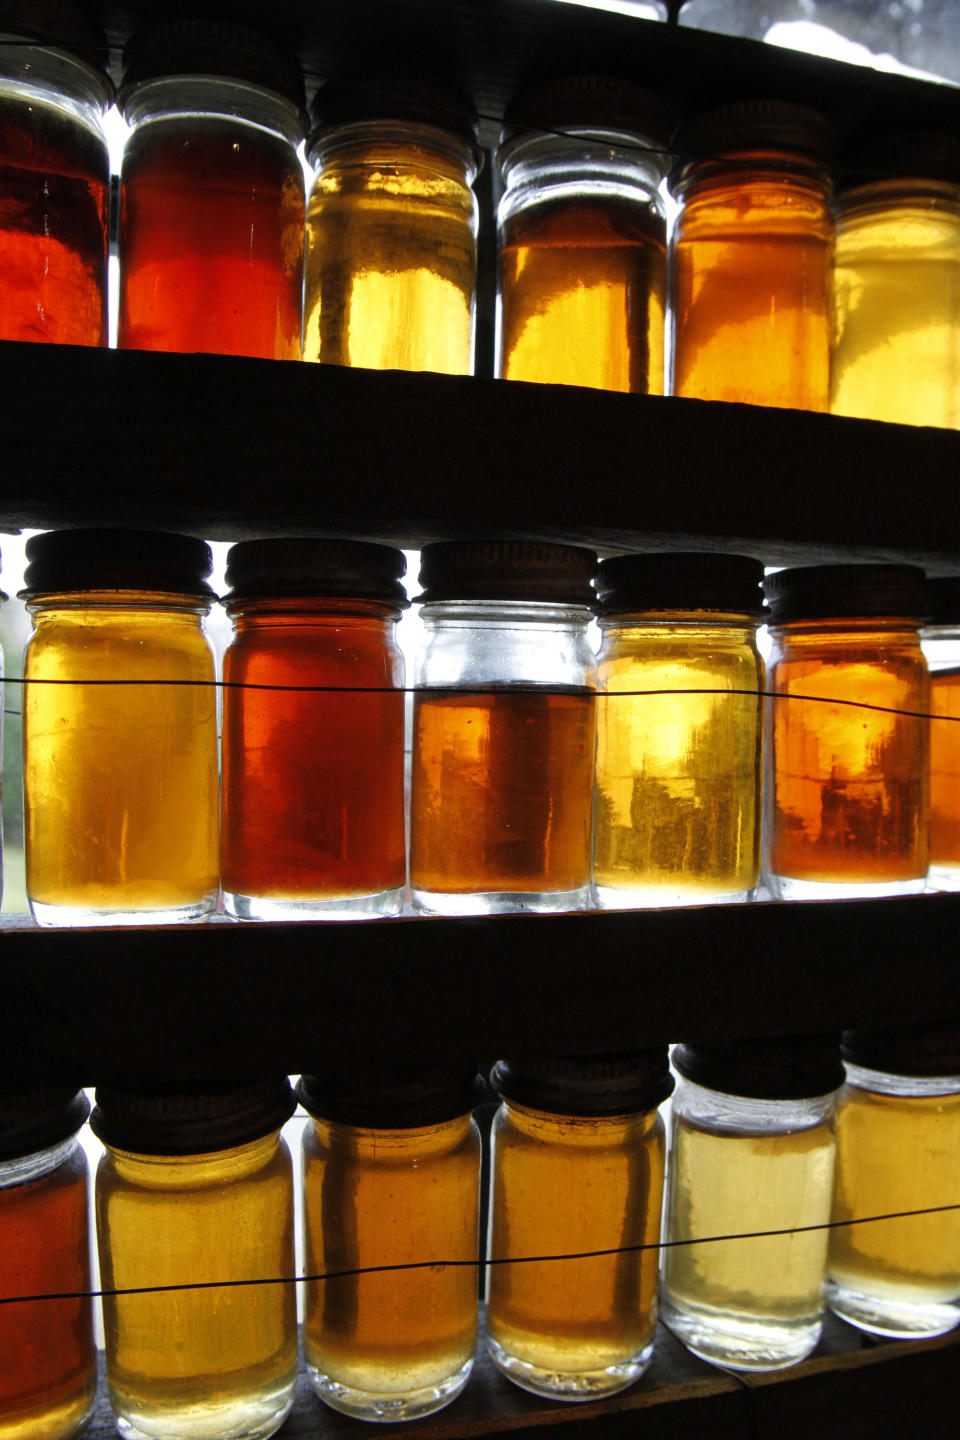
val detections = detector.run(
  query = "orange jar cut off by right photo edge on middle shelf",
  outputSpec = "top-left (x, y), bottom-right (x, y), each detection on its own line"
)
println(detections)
top-left (920, 576), bottom-right (960, 890)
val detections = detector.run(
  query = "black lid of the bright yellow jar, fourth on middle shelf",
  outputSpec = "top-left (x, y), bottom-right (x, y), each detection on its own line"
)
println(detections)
top-left (597, 552), bottom-right (766, 618)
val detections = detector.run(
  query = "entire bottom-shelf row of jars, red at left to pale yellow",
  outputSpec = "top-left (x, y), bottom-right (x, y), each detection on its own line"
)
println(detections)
top-left (0, 1022), bottom-right (960, 1440)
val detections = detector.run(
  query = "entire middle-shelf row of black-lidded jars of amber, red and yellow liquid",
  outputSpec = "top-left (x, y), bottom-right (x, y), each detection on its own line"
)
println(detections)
top-left (7, 530), bottom-right (960, 924)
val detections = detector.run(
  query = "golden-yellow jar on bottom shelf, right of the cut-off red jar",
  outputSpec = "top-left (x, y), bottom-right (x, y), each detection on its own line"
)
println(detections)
top-left (91, 1079), bottom-right (296, 1440)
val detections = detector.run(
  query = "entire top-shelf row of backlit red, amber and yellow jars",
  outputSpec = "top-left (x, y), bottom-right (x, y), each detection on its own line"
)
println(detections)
top-left (7, 11), bottom-right (960, 426)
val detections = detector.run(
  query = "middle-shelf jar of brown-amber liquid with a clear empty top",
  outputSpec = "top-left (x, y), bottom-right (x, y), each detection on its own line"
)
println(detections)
top-left (410, 540), bottom-right (596, 914)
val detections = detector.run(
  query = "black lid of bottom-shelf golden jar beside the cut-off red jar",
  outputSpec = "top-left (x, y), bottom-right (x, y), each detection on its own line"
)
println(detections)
top-left (91, 1076), bottom-right (296, 1155)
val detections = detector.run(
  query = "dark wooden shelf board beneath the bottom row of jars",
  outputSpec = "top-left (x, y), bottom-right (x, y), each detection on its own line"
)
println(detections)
top-left (88, 1316), bottom-right (960, 1440)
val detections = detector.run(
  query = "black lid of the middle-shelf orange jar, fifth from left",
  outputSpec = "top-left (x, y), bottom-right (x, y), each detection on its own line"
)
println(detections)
top-left (763, 564), bottom-right (927, 625)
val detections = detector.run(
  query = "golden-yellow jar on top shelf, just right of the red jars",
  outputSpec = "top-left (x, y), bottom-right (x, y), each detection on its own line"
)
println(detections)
top-left (304, 78), bottom-right (479, 374)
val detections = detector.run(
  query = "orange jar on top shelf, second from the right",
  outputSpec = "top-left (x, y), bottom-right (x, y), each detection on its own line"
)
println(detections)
top-left (671, 101), bottom-right (833, 410)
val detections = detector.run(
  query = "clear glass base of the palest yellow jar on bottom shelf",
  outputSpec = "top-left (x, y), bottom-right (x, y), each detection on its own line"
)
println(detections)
top-left (661, 1293), bottom-right (823, 1371)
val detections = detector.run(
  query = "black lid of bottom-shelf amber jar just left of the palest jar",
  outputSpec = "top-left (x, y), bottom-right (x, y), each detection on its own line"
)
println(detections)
top-left (489, 1045), bottom-right (674, 1117)
